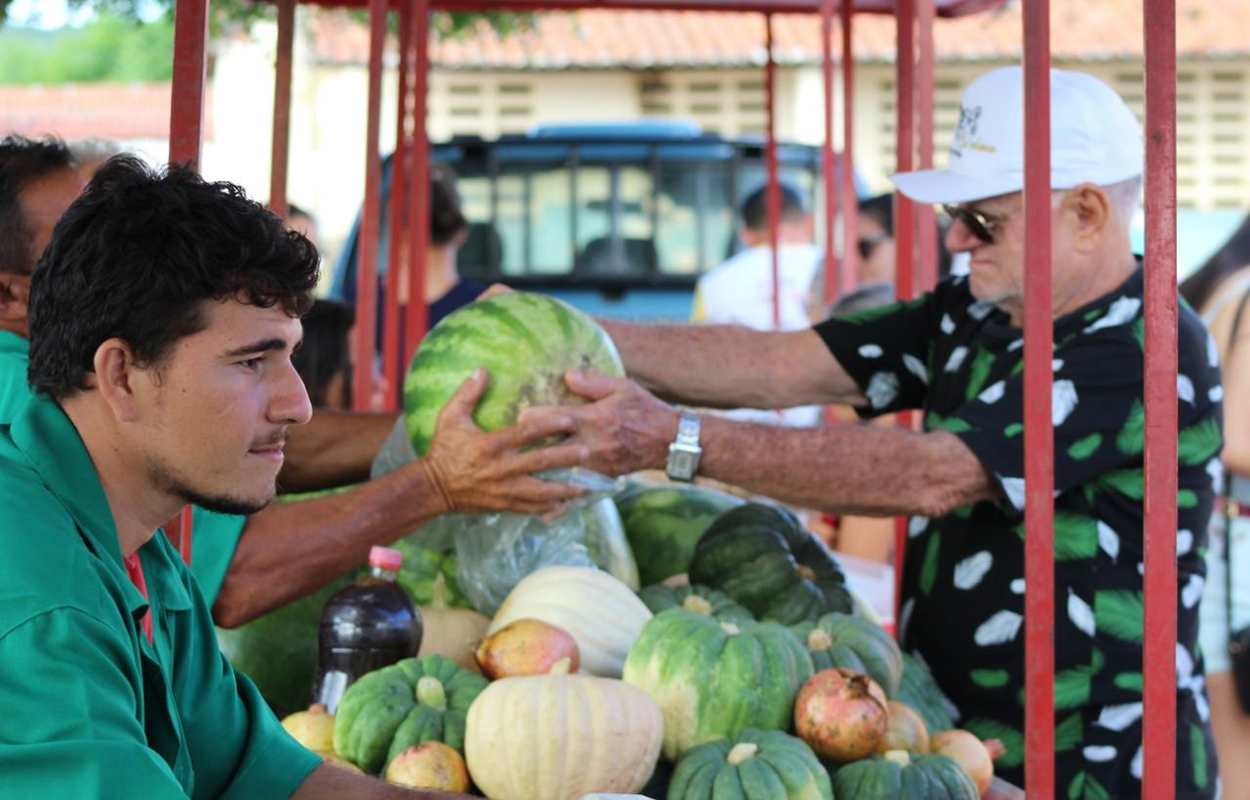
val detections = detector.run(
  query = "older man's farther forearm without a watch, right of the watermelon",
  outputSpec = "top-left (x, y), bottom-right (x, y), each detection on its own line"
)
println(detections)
top-left (599, 320), bottom-right (860, 409)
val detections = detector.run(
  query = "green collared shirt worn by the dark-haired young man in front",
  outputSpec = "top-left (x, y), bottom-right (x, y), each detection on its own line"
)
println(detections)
top-left (0, 398), bottom-right (320, 799)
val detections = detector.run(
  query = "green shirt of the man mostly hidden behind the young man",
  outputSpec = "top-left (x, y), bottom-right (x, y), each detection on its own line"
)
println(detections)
top-left (0, 330), bottom-right (248, 608)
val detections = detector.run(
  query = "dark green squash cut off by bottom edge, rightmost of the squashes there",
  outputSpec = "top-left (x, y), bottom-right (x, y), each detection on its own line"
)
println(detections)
top-left (834, 750), bottom-right (981, 800)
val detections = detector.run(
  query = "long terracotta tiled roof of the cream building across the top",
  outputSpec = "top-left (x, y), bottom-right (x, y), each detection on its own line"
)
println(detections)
top-left (310, 0), bottom-right (1250, 69)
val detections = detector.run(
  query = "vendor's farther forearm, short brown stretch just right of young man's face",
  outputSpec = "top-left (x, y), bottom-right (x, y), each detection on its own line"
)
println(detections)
top-left (279, 409), bottom-right (396, 491)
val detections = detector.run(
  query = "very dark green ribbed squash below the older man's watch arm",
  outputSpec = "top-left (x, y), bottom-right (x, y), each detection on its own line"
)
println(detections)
top-left (690, 503), bottom-right (854, 625)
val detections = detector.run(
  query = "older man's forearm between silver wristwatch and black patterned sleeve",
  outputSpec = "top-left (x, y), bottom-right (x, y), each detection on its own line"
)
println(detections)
top-left (699, 415), bottom-right (998, 516)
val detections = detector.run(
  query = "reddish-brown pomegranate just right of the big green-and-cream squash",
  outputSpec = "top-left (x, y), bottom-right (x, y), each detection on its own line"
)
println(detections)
top-left (794, 668), bottom-right (889, 764)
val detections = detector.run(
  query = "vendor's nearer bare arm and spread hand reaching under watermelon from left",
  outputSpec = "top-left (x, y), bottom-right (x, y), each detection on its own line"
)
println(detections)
top-left (213, 373), bottom-right (588, 628)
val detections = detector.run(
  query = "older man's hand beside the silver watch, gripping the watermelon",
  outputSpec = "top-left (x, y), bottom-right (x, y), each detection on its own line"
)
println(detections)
top-left (520, 370), bottom-right (678, 475)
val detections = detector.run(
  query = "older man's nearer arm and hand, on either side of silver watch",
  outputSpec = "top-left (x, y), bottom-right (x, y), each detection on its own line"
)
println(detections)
top-left (523, 374), bottom-right (999, 516)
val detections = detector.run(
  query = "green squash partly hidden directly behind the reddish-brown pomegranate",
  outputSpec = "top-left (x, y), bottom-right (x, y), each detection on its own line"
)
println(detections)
top-left (791, 611), bottom-right (903, 698)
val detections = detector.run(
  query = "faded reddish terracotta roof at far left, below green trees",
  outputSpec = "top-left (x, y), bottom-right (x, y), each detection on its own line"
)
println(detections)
top-left (0, 81), bottom-right (213, 139)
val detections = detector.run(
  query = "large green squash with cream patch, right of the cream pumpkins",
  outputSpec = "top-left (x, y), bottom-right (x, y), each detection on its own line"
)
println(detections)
top-left (623, 609), bottom-right (813, 759)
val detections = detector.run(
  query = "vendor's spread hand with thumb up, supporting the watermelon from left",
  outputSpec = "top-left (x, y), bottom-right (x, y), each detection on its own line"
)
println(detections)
top-left (419, 368), bottom-right (588, 514)
